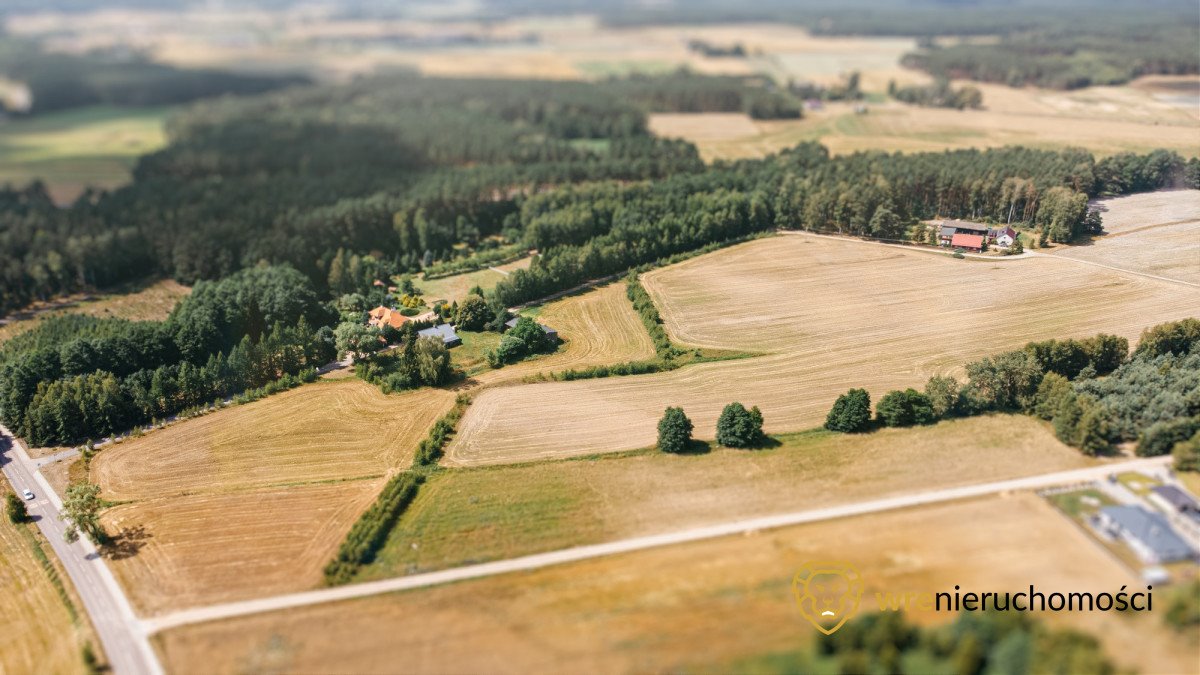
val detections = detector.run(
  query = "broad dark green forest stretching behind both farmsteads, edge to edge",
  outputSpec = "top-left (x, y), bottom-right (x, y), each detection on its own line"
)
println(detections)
top-left (0, 74), bottom-right (1200, 313)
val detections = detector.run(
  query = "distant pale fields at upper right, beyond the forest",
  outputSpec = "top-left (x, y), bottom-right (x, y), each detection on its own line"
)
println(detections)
top-left (650, 78), bottom-right (1200, 161)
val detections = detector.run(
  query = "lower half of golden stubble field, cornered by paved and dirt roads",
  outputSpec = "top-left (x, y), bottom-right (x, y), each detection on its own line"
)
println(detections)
top-left (103, 478), bottom-right (383, 614)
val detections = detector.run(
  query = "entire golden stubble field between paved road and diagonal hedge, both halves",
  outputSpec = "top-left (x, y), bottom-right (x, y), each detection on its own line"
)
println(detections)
top-left (91, 380), bottom-right (454, 614)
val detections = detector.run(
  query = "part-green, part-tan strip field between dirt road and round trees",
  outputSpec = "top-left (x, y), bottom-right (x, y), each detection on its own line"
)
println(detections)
top-left (362, 416), bottom-right (1093, 579)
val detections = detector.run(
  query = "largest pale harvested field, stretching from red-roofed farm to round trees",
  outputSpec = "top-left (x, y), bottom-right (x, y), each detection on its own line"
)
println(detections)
top-left (446, 234), bottom-right (1200, 465)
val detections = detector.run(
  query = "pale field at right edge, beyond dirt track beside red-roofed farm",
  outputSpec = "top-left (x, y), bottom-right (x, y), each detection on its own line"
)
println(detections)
top-left (1054, 190), bottom-right (1200, 286)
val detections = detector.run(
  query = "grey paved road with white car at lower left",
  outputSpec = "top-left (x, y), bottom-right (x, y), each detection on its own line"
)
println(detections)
top-left (0, 426), bottom-right (162, 675)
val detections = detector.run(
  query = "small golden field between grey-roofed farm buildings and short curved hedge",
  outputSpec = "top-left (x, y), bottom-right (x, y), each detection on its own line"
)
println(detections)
top-left (474, 281), bottom-right (654, 384)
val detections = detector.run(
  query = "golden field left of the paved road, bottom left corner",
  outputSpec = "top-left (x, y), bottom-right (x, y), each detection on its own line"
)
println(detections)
top-left (0, 484), bottom-right (88, 673)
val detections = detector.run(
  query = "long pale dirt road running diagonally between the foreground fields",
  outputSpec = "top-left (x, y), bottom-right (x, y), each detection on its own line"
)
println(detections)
top-left (143, 456), bottom-right (1171, 634)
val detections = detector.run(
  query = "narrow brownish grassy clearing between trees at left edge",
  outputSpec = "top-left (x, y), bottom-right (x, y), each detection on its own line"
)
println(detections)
top-left (0, 279), bottom-right (191, 344)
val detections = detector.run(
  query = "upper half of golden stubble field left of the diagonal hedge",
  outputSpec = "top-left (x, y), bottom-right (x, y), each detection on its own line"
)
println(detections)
top-left (91, 378), bottom-right (454, 501)
